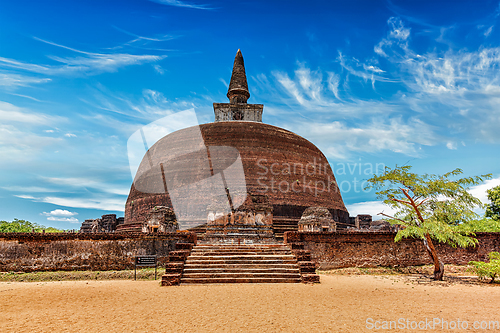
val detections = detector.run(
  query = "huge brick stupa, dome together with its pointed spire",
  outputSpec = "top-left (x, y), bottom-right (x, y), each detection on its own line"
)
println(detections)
top-left (118, 50), bottom-right (350, 236)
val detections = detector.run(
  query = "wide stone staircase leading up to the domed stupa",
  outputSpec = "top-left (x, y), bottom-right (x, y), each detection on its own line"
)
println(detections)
top-left (162, 243), bottom-right (319, 286)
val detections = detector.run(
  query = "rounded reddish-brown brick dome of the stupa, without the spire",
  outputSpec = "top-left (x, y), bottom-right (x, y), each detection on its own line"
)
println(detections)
top-left (120, 121), bottom-right (349, 228)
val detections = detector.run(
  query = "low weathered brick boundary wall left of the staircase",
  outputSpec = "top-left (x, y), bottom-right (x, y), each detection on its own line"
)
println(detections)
top-left (0, 232), bottom-right (196, 272)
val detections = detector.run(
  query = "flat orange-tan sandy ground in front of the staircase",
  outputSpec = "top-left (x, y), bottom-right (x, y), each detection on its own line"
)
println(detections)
top-left (0, 275), bottom-right (500, 332)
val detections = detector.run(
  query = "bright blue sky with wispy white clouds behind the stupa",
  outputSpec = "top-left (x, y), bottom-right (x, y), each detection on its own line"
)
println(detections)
top-left (0, 0), bottom-right (500, 229)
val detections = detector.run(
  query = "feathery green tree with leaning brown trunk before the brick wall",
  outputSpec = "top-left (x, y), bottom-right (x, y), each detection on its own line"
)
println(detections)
top-left (367, 165), bottom-right (491, 280)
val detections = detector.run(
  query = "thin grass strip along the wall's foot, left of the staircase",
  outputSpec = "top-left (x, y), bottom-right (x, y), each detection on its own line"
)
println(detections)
top-left (0, 267), bottom-right (160, 282)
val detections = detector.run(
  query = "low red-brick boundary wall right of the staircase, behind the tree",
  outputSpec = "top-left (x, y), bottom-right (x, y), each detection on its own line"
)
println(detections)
top-left (284, 231), bottom-right (500, 269)
